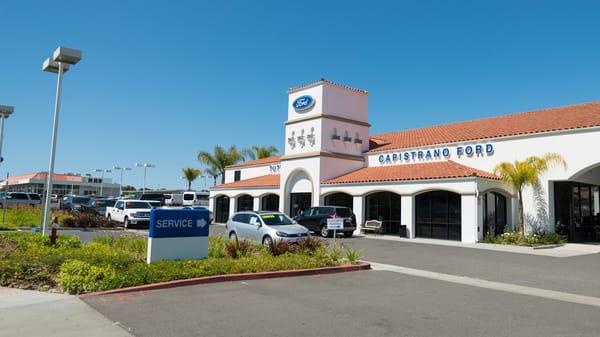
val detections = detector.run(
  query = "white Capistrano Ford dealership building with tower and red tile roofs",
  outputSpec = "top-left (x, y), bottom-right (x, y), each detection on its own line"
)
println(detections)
top-left (210, 79), bottom-right (600, 242)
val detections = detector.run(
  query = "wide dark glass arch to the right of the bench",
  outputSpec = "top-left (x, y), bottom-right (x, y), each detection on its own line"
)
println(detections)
top-left (415, 191), bottom-right (461, 241)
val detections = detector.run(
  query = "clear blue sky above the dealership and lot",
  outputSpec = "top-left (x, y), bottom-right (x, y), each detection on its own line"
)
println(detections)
top-left (0, 0), bottom-right (600, 188)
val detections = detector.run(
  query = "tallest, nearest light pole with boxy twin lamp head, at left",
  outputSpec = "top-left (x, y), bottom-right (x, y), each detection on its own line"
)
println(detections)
top-left (42, 47), bottom-right (81, 235)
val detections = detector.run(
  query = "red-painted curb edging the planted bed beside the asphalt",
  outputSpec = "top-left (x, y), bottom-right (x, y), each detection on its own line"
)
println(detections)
top-left (79, 262), bottom-right (371, 297)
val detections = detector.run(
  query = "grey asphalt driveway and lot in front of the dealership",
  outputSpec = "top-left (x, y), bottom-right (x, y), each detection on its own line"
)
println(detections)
top-left (76, 225), bottom-right (600, 336)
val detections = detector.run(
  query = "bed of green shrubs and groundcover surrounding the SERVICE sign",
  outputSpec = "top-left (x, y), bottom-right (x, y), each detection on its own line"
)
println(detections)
top-left (0, 232), bottom-right (358, 294)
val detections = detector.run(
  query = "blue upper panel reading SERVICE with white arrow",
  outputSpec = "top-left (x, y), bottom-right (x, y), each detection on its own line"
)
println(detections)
top-left (148, 208), bottom-right (210, 238)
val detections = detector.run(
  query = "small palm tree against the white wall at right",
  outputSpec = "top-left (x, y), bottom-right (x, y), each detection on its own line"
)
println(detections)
top-left (494, 153), bottom-right (567, 235)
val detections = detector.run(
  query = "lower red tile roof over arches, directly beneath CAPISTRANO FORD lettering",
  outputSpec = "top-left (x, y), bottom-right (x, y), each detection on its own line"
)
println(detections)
top-left (324, 160), bottom-right (499, 184)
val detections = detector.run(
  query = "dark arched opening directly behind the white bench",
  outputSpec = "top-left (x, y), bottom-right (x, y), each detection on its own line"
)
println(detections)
top-left (365, 192), bottom-right (402, 235)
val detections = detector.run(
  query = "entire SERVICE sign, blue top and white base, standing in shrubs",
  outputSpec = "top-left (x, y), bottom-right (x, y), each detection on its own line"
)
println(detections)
top-left (146, 209), bottom-right (210, 263)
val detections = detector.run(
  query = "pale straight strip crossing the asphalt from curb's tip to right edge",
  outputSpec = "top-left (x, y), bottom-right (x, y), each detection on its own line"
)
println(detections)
top-left (364, 261), bottom-right (600, 308)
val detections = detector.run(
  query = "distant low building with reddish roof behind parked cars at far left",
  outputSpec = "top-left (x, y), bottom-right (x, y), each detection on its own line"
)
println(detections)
top-left (0, 172), bottom-right (120, 196)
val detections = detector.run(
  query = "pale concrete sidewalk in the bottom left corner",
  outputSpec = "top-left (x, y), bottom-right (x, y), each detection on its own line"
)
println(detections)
top-left (0, 287), bottom-right (131, 337)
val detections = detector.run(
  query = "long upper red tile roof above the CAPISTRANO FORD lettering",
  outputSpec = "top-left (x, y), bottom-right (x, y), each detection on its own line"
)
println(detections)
top-left (369, 102), bottom-right (600, 152)
